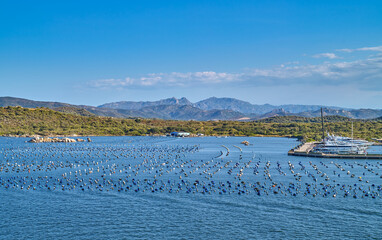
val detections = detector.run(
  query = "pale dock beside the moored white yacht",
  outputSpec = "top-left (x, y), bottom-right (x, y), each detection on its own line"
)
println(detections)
top-left (288, 142), bottom-right (382, 159)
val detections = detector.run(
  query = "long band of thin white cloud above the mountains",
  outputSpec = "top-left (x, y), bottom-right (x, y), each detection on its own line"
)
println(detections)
top-left (89, 56), bottom-right (382, 91)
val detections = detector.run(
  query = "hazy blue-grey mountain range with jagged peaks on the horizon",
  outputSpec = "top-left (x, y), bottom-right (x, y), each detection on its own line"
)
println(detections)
top-left (0, 97), bottom-right (382, 121)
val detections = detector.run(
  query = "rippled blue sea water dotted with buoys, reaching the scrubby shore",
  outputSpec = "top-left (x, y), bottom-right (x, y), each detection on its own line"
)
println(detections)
top-left (0, 137), bottom-right (382, 239)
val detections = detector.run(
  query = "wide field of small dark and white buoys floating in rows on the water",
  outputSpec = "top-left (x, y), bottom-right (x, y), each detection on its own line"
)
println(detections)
top-left (0, 140), bottom-right (382, 198)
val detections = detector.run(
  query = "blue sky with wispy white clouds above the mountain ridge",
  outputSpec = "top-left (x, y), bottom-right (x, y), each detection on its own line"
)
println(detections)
top-left (0, 0), bottom-right (382, 108)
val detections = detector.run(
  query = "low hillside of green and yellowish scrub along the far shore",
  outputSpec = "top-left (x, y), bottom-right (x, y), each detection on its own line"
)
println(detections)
top-left (0, 107), bottom-right (382, 140)
